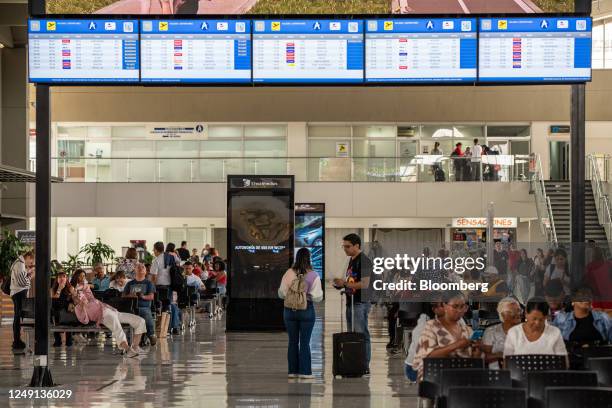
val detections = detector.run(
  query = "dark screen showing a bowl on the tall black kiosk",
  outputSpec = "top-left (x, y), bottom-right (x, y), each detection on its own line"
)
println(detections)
top-left (228, 193), bottom-right (293, 299)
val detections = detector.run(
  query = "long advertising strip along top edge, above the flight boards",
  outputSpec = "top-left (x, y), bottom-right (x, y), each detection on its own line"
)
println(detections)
top-left (45, 0), bottom-right (575, 15)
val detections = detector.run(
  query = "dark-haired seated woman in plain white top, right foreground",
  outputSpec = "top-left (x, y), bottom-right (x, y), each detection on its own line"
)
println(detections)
top-left (504, 298), bottom-right (567, 364)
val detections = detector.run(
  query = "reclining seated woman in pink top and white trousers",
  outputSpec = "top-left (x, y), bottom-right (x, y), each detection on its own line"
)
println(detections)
top-left (70, 269), bottom-right (147, 357)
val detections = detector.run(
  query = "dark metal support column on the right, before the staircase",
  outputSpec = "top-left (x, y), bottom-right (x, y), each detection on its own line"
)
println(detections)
top-left (570, 84), bottom-right (586, 282)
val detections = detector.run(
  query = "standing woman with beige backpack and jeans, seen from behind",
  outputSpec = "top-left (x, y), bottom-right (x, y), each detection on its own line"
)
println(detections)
top-left (278, 248), bottom-right (323, 379)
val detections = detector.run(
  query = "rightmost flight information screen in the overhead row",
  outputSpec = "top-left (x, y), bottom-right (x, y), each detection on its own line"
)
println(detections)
top-left (479, 17), bottom-right (592, 82)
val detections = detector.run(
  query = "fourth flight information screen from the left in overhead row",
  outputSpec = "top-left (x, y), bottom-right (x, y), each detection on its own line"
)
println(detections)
top-left (365, 18), bottom-right (478, 82)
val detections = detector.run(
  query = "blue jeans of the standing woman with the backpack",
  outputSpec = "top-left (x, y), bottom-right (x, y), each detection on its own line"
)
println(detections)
top-left (283, 302), bottom-right (315, 375)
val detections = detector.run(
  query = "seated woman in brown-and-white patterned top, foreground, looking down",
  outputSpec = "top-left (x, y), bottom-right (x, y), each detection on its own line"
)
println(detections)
top-left (412, 291), bottom-right (480, 381)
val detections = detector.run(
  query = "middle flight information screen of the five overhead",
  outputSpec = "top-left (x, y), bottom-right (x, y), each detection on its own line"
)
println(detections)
top-left (253, 20), bottom-right (364, 83)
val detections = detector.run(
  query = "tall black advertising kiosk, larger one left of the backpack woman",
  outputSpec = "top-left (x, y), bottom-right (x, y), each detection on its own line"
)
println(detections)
top-left (226, 176), bottom-right (295, 331)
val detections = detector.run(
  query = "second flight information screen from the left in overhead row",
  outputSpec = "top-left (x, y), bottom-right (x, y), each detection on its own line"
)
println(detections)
top-left (140, 20), bottom-right (251, 83)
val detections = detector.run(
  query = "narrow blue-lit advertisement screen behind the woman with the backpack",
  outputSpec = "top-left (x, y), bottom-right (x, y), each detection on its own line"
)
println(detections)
top-left (295, 212), bottom-right (325, 279)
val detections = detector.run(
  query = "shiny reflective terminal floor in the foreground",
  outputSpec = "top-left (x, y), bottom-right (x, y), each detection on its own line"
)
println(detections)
top-left (0, 289), bottom-right (417, 408)
